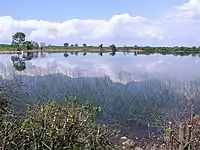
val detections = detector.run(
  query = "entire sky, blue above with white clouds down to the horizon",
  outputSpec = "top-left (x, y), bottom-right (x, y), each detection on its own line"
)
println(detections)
top-left (0, 0), bottom-right (200, 46)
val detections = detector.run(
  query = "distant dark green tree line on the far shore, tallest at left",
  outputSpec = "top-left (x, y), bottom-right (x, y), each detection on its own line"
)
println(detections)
top-left (8, 32), bottom-right (200, 54)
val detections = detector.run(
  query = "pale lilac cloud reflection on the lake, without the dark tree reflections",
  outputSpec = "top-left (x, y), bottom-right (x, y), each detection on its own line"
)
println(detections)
top-left (0, 53), bottom-right (200, 82)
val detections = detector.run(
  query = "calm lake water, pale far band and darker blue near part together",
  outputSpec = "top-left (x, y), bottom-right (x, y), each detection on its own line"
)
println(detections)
top-left (0, 52), bottom-right (200, 135)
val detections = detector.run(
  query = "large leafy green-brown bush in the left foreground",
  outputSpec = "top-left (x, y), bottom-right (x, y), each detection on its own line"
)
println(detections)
top-left (0, 96), bottom-right (119, 150)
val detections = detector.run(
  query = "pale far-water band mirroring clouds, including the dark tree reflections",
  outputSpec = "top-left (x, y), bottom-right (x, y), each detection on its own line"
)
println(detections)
top-left (0, 52), bottom-right (200, 81)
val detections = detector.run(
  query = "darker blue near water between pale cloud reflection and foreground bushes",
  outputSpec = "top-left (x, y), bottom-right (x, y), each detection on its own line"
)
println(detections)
top-left (2, 74), bottom-right (199, 135)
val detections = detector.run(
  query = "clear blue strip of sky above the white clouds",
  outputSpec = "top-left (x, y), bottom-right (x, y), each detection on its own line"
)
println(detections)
top-left (0, 0), bottom-right (184, 21)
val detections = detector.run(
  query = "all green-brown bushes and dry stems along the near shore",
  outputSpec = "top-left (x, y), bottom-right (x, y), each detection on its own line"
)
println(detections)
top-left (0, 88), bottom-right (200, 150)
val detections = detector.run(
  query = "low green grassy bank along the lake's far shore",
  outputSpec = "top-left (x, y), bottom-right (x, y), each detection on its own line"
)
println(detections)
top-left (0, 44), bottom-right (200, 56)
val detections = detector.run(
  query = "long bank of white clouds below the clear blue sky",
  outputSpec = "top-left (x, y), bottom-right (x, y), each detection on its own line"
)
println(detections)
top-left (0, 0), bottom-right (200, 45)
